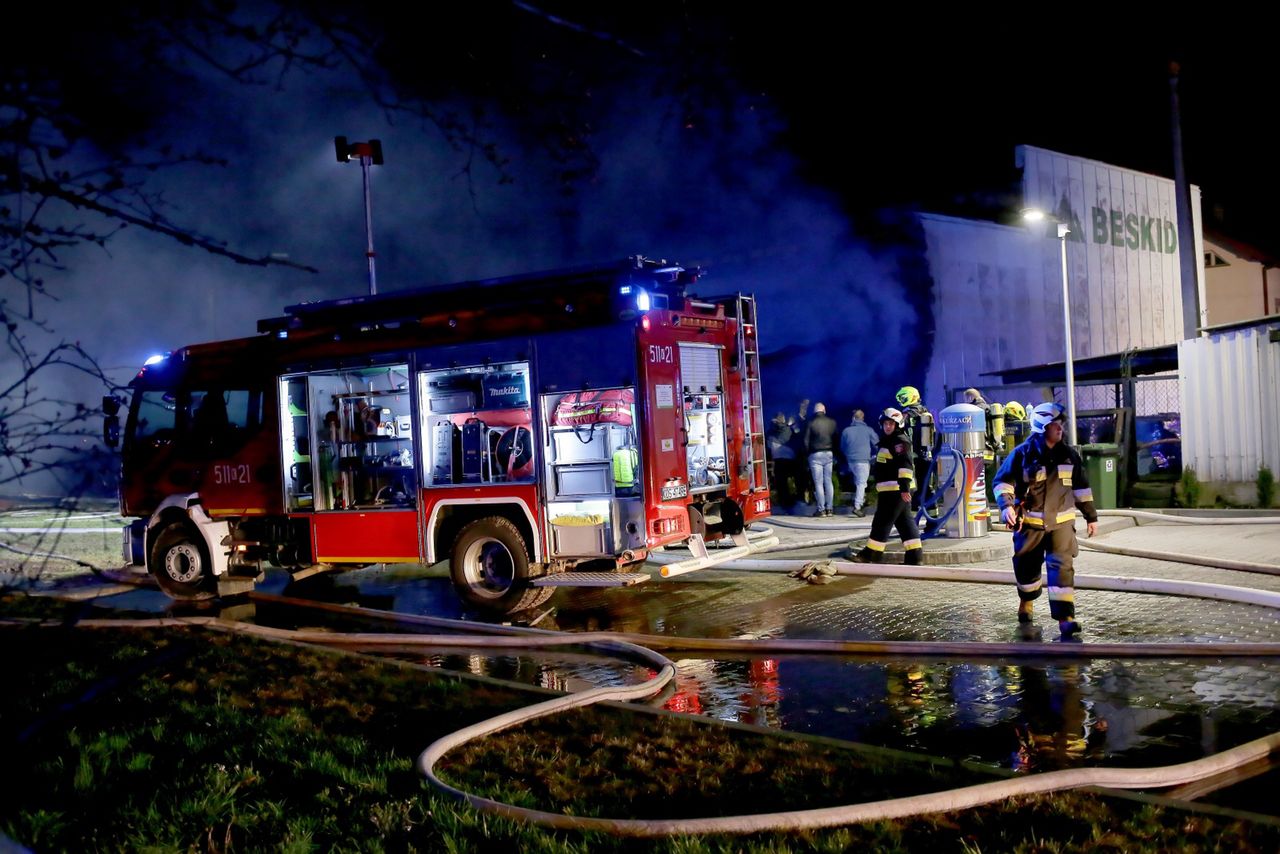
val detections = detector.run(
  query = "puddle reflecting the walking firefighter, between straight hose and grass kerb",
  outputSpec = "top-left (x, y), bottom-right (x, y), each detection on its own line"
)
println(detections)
top-left (668, 657), bottom-right (1280, 769)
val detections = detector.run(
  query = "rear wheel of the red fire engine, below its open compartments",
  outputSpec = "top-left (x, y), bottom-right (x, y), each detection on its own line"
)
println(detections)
top-left (449, 516), bottom-right (553, 613)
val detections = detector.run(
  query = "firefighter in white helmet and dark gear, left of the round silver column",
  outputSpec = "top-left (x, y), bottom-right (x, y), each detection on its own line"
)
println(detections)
top-left (854, 410), bottom-right (923, 566)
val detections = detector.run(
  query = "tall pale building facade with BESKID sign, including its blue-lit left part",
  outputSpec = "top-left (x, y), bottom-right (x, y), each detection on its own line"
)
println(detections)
top-left (920, 146), bottom-right (1203, 409)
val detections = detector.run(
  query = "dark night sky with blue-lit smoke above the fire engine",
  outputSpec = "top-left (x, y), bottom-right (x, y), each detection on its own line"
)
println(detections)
top-left (0, 3), bottom-right (1280, 473)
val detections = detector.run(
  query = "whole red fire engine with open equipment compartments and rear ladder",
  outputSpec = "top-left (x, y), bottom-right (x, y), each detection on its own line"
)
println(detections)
top-left (106, 257), bottom-right (769, 612)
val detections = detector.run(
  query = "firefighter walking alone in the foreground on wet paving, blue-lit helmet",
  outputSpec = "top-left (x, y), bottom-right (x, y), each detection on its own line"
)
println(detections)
top-left (996, 403), bottom-right (1098, 638)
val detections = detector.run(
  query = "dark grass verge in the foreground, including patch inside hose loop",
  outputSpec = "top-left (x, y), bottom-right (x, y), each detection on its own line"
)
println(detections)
top-left (0, 603), bottom-right (1280, 851)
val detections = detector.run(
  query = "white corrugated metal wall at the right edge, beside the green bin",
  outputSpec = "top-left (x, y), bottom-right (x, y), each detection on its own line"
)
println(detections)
top-left (1178, 324), bottom-right (1280, 481)
